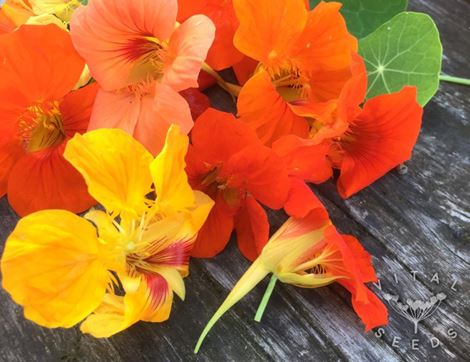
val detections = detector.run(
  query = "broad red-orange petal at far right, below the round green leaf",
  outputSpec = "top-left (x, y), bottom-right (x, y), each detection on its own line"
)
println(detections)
top-left (338, 87), bottom-right (423, 198)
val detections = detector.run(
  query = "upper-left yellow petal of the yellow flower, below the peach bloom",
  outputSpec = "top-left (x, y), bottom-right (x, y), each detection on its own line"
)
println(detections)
top-left (64, 129), bottom-right (153, 215)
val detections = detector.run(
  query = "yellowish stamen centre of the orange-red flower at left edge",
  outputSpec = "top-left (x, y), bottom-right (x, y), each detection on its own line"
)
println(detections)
top-left (18, 101), bottom-right (65, 152)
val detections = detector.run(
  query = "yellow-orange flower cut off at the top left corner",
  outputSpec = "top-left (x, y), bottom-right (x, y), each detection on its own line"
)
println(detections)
top-left (0, 0), bottom-right (82, 34)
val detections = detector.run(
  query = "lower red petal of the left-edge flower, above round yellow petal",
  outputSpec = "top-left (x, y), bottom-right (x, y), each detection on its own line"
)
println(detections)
top-left (7, 142), bottom-right (96, 216)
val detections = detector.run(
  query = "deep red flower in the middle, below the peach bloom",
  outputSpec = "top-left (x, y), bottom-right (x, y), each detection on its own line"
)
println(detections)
top-left (186, 109), bottom-right (289, 260)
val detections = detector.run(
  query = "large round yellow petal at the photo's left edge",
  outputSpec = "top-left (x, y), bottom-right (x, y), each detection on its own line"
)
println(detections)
top-left (2, 210), bottom-right (110, 328)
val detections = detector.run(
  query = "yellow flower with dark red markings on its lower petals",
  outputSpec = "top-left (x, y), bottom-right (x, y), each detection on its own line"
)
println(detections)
top-left (1, 126), bottom-right (213, 337)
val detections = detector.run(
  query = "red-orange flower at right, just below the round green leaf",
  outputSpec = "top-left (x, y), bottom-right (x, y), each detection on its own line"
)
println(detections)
top-left (279, 55), bottom-right (423, 198)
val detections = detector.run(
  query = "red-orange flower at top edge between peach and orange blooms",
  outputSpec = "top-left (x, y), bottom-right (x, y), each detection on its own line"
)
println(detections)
top-left (178, 0), bottom-right (243, 70)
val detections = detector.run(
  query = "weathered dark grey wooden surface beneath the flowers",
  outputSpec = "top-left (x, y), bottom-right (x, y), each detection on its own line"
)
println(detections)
top-left (0, 0), bottom-right (470, 361)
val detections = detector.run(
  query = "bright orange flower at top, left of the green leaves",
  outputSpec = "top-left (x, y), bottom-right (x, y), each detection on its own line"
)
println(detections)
top-left (234, 0), bottom-right (357, 145)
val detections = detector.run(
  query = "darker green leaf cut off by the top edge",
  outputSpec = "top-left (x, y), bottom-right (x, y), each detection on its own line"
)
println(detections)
top-left (310, 0), bottom-right (408, 39)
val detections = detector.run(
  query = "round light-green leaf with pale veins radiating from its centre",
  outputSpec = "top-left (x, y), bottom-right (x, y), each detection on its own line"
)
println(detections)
top-left (359, 12), bottom-right (442, 106)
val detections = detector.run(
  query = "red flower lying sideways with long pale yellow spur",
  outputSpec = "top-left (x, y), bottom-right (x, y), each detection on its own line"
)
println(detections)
top-left (195, 208), bottom-right (388, 352)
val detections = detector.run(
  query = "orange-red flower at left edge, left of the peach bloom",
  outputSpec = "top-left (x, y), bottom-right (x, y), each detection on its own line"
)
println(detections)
top-left (0, 25), bottom-right (97, 215)
